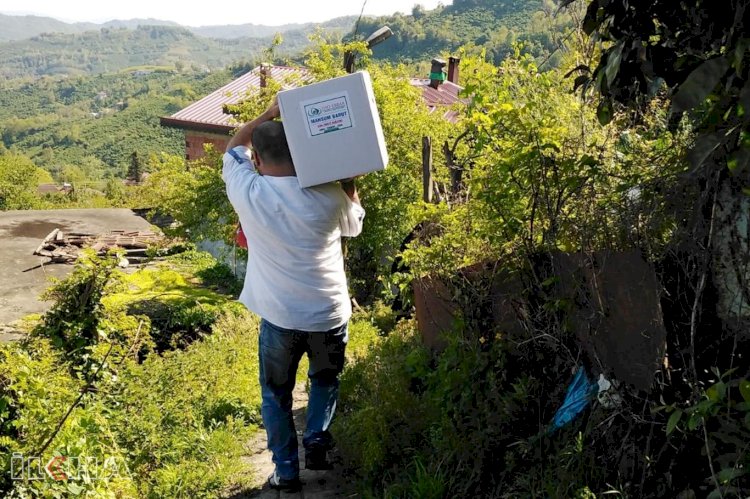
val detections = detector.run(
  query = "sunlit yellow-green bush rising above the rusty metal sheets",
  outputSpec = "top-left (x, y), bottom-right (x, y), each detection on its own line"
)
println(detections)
top-left (403, 52), bottom-right (689, 282)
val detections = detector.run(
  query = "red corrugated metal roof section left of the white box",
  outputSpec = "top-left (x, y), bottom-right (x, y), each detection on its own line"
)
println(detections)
top-left (161, 66), bottom-right (310, 132)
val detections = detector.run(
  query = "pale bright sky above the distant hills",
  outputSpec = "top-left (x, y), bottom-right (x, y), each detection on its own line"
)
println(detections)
top-left (0, 0), bottom-right (451, 26)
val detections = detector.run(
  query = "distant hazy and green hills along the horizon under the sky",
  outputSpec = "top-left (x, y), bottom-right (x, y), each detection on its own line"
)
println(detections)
top-left (0, 0), bottom-right (572, 78)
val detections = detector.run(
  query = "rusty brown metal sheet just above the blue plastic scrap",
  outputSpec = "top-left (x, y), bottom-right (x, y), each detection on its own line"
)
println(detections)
top-left (552, 251), bottom-right (667, 391)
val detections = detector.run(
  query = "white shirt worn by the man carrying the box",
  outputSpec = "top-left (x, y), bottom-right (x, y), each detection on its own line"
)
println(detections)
top-left (222, 146), bottom-right (365, 331)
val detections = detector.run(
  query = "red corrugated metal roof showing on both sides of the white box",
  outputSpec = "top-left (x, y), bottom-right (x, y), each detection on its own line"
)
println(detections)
top-left (161, 66), bottom-right (463, 133)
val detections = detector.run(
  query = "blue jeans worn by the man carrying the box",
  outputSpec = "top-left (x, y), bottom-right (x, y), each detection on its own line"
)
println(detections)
top-left (258, 319), bottom-right (349, 479)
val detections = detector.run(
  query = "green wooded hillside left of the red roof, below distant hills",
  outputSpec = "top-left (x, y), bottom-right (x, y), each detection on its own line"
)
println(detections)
top-left (0, 70), bottom-right (231, 181)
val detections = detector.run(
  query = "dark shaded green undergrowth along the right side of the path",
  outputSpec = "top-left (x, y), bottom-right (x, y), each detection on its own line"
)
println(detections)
top-left (334, 310), bottom-right (750, 499)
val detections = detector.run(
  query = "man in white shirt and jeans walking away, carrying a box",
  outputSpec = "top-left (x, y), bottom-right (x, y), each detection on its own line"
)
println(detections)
top-left (222, 94), bottom-right (365, 491)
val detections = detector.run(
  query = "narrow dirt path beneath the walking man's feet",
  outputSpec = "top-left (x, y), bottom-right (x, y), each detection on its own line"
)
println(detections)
top-left (228, 382), bottom-right (357, 499)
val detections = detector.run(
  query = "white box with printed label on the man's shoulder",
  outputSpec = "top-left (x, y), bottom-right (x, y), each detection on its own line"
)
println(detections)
top-left (279, 71), bottom-right (388, 187)
